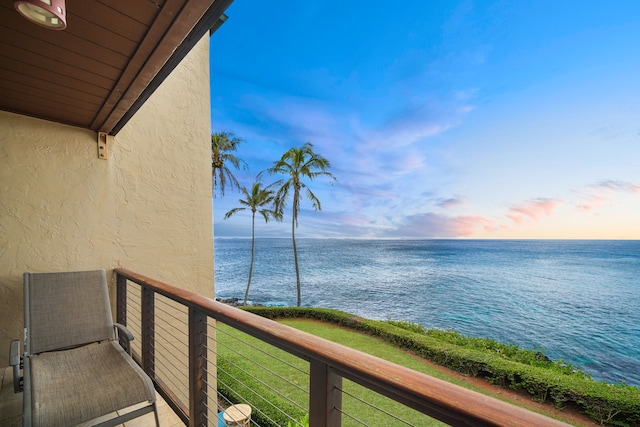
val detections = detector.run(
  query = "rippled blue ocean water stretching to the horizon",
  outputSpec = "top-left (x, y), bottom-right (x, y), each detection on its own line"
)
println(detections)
top-left (215, 238), bottom-right (640, 386)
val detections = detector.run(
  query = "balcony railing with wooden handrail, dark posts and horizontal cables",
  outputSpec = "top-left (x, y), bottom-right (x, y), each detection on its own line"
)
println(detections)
top-left (115, 268), bottom-right (566, 427)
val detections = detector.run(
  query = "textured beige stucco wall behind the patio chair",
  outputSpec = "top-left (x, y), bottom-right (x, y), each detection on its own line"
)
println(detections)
top-left (0, 37), bottom-right (213, 366)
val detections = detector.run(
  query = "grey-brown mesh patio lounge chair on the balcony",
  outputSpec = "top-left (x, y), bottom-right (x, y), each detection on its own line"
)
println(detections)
top-left (11, 270), bottom-right (160, 427)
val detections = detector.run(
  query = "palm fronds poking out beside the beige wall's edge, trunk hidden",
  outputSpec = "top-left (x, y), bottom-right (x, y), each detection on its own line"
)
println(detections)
top-left (211, 132), bottom-right (247, 197)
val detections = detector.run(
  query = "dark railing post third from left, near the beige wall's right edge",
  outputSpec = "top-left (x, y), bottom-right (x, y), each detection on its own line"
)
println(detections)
top-left (189, 307), bottom-right (208, 427)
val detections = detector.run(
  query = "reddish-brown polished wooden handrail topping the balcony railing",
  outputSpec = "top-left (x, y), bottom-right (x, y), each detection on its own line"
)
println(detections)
top-left (115, 268), bottom-right (567, 427)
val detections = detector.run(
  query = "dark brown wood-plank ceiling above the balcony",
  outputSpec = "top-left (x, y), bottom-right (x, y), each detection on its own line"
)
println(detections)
top-left (0, 0), bottom-right (233, 135)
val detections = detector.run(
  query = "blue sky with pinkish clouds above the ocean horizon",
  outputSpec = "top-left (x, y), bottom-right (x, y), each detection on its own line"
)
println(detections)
top-left (211, 0), bottom-right (640, 239)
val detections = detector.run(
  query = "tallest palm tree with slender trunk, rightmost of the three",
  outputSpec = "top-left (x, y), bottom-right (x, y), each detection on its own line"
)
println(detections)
top-left (258, 142), bottom-right (335, 307)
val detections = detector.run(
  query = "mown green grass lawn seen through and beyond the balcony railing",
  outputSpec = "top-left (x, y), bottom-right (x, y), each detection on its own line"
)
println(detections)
top-left (217, 319), bottom-right (592, 427)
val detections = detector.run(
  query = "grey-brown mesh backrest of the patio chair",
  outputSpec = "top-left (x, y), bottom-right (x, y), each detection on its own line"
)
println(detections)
top-left (24, 270), bottom-right (114, 355)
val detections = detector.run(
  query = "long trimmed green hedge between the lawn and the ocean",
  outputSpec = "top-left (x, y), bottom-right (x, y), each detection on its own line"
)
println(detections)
top-left (244, 307), bottom-right (640, 427)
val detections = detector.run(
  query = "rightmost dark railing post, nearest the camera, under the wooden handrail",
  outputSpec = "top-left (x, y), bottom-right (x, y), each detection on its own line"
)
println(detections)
top-left (309, 359), bottom-right (342, 427)
